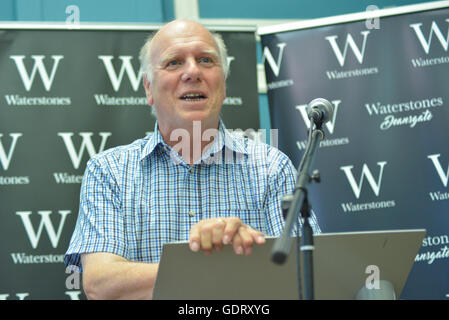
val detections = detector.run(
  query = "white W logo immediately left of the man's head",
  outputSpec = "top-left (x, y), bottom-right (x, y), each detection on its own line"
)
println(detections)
top-left (98, 56), bottom-right (142, 91)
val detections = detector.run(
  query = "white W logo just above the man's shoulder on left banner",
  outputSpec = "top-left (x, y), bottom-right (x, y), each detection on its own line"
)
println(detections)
top-left (58, 132), bottom-right (112, 169)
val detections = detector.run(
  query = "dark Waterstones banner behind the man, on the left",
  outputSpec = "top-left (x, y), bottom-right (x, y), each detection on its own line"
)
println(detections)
top-left (0, 24), bottom-right (259, 300)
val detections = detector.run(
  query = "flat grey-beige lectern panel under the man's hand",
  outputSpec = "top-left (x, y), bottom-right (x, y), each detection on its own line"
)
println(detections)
top-left (153, 229), bottom-right (426, 300)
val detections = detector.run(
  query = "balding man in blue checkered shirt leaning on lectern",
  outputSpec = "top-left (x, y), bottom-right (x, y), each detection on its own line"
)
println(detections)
top-left (65, 20), bottom-right (320, 299)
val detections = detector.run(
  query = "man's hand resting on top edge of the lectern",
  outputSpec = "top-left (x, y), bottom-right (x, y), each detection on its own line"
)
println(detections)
top-left (189, 217), bottom-right (265, 255)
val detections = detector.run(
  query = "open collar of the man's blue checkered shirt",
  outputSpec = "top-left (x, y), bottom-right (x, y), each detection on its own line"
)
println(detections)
top-left (140, 119), bottom-right (248, 160)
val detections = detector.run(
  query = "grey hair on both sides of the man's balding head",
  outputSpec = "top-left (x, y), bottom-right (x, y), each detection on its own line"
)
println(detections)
top-left (139, 32), bottom-right (229, 82)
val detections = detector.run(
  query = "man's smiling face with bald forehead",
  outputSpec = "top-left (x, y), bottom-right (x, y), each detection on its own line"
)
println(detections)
top-left (144, 21), bottom-right (226, 131)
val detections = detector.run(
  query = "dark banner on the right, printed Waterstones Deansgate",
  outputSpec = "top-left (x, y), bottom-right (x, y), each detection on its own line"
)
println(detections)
top-left (259, 1), bottom-right (449, 299)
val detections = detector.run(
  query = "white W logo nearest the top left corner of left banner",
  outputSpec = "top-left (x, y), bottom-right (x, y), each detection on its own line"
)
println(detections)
top-left (9, 56), bottom-right (64, 91)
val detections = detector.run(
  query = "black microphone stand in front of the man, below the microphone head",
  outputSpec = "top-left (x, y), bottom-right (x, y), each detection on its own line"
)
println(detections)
top-left (272, 121), bottom-right (324, 300)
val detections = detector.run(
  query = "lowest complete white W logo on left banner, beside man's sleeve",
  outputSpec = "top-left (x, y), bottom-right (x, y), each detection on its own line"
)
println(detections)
top-left (16, 210), bottom-right (70, 249)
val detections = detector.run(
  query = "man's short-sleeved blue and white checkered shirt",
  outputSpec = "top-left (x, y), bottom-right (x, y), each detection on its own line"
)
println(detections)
top-left (64, 121), bottom-right (320, 270)
